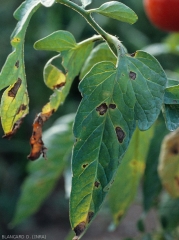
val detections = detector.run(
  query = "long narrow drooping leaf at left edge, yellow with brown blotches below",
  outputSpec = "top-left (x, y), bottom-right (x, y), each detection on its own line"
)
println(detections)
top-left (0, 0), bottom-right (55, 138)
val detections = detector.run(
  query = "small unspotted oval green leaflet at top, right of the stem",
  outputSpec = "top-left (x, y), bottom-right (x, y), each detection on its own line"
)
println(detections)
top-left (90, 1), bottom-right (138, 24)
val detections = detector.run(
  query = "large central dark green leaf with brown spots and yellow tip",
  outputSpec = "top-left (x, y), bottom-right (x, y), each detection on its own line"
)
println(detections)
top-left (70, 51), bottom-right (166, 236)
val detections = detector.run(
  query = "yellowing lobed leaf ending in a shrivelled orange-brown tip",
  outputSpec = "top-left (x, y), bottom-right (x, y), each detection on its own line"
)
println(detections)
top-left (28, 31), bottom-right (94, 160)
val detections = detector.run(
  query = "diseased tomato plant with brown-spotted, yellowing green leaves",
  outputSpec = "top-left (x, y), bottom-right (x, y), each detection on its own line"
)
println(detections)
top-left (0, 0), bottom-right (179, 240)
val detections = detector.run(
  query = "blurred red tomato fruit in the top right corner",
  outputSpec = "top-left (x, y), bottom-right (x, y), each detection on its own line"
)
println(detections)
top-left (143, 0), bottom-right (179, 32)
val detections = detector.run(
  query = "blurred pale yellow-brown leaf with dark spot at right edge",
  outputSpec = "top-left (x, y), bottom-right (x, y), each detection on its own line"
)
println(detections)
top-left (158, 129), bottom-right (179, 198)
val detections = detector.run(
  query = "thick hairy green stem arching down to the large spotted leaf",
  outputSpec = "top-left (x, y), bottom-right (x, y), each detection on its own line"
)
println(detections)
top-left (56, 0), bottom-right (120, 55)
